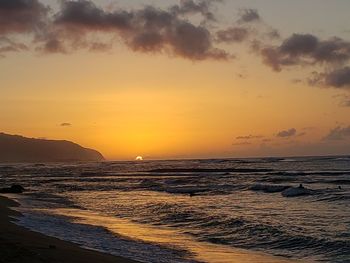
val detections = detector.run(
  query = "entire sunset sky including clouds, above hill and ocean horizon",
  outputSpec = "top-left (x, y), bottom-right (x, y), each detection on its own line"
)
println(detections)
top-left (0, 0), bottom-right (350, 160)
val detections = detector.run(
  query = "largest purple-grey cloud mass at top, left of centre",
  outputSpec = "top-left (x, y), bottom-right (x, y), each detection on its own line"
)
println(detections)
top-left (41, 0), bottom-right (230, 60)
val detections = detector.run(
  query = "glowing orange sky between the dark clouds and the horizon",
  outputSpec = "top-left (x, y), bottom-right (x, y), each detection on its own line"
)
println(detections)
top-left (0, 1), bottom-right (350, 159)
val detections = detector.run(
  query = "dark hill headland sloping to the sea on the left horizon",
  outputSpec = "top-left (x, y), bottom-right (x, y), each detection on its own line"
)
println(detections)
top-left (0, 133), bottom-right (104, 162)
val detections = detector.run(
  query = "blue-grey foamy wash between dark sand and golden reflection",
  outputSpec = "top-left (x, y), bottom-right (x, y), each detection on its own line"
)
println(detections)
top-left (16, 213), bottom-right (196, 263)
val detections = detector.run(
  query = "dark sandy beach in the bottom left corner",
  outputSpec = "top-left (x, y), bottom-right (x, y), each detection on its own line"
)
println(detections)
top-left (0, 196), bottom-right (137, 263)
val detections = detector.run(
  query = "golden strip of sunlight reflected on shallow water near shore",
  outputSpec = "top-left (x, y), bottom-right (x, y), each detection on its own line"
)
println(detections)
top-left (40, 208), bottom-right (299, 263)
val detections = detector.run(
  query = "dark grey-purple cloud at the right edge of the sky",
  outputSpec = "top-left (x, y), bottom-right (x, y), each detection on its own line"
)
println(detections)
top-left (252, 34), bottom-right (350, 88)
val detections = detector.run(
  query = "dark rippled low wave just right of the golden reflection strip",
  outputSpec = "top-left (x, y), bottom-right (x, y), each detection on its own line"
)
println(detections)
top-left (142, 203), bottom-right (350, 259)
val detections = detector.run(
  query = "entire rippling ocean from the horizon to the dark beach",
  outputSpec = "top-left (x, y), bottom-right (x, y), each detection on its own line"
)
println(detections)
top-left (0, 156), bottom-right (350, 263)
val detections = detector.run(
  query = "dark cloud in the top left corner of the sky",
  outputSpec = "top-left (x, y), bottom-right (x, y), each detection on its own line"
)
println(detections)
top-left (0, 0), bottom-right (48, 35)
